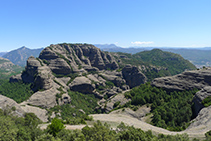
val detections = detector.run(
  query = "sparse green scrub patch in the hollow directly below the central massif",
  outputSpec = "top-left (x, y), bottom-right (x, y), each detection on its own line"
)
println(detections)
top-left (49, 91), bottom-right (98, 124)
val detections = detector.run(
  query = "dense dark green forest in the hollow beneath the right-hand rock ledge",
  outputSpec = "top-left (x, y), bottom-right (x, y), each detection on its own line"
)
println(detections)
top-left (125, 83), bottom-right (197, 131)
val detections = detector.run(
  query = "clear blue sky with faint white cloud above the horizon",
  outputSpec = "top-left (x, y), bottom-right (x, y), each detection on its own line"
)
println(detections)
top-left (0, 0), bottom-right (211, 52)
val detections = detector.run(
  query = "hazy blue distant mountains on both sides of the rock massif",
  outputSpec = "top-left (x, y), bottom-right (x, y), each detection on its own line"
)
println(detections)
top-left (0, 44), bottom-right (211, 68)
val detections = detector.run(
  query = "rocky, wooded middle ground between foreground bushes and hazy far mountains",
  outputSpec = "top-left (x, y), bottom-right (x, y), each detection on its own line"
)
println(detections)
top-left (0, 43), bottom-right (211, 139)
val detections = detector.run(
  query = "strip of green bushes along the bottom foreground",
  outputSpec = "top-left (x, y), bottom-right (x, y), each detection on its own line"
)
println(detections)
top-left (0, 110), bottom-right (204, 141)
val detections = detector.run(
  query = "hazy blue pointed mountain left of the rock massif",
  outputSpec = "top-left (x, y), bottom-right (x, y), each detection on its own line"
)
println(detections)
top-left (3, 46), bottom-right (43, 67)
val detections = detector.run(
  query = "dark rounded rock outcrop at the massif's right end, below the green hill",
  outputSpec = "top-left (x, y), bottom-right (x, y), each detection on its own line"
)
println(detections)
top-left (122, 65), bottom-right (147, 88)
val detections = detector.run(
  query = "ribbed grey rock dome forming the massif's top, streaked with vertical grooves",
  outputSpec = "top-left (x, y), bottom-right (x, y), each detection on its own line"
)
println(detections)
top-left (39, 44), bottom-right (118, 74)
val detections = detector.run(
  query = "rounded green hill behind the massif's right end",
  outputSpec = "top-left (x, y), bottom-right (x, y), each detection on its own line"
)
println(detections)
top-left (113, 49), bottom-right (196, 81)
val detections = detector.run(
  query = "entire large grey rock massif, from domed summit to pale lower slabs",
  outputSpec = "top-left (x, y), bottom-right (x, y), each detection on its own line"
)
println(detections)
top-left (10, 44), bottom-right (147, 108)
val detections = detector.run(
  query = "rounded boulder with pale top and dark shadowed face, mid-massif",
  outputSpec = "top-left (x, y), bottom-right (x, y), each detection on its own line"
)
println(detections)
top-left (69, 76), bottom-right (95, 94)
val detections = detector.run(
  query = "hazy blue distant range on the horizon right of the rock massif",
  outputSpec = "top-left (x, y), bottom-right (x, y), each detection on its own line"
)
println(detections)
top-left (95, 44), bottom-right (211, 68)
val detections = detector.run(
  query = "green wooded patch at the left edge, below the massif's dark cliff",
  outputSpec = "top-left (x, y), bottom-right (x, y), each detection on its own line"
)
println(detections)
top-left (0, 81), bottom-right (33, 103)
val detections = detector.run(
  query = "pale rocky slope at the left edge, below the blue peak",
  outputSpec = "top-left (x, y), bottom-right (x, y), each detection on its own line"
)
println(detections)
top-left (0, 57), bottom-right (23, 80)
